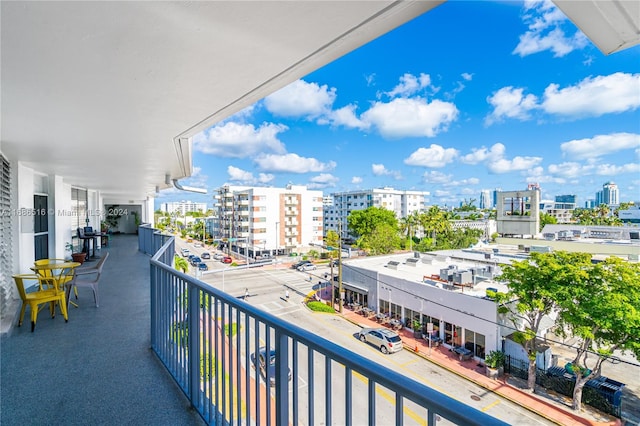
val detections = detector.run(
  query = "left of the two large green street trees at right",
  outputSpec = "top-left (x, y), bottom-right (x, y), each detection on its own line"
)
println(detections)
top-left (496, 252), bottom-right (591, 392)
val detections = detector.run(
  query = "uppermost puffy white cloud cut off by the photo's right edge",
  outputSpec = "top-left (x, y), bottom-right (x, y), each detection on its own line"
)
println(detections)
top-left (541, 72), bottom-right (640, 117)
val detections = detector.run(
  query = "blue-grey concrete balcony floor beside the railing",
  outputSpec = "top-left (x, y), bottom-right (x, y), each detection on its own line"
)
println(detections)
top-left (0, 235), bottom-right (204, 426)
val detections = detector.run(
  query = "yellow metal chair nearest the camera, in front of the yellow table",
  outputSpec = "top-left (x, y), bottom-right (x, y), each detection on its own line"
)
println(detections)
top-left (13, 274), bottom-right (69, 333)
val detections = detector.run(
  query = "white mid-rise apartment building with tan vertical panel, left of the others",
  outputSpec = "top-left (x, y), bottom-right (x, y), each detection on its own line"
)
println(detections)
top-left (213, 185), bottom-right (323, 257)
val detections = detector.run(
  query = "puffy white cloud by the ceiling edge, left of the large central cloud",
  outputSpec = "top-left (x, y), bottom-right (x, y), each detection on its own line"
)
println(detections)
top-left (264, 80), bottom-right (336, 119)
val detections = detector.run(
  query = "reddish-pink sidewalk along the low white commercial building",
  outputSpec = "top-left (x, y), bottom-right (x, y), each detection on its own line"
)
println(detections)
top-left (342, 308), bottom-right (622, 426)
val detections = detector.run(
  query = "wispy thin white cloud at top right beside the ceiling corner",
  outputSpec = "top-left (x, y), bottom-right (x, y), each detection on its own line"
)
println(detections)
top-left (512, 1), bottom-right (588, 58)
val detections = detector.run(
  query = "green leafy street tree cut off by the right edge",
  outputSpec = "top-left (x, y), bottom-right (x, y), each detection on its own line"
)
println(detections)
top-left (559, 257), bottom-right (640, 411)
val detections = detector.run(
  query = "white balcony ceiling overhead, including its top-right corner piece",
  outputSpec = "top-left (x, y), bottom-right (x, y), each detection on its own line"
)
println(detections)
top-left (0, 0), bottom-right (640, 199)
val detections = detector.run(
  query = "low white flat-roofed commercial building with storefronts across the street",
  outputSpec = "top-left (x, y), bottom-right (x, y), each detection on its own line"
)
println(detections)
top-left (342, 248), bottom-right (526, 360)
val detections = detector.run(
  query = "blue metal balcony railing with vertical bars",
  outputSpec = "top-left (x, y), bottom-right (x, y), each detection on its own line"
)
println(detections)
top-left (144, 228), bottom-right (505, 426)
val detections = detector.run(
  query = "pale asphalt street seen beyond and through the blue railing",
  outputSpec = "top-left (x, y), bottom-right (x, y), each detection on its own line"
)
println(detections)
top-left (182, 243), bottom-right (553, 425)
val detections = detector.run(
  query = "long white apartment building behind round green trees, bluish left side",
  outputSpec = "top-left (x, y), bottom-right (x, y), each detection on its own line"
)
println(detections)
top-left (324, 187), bottom-right (430, 238)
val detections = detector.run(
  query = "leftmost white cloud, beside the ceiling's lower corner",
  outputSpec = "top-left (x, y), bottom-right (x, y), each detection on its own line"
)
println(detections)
top-left (193, 122), bottom-right (288, 158)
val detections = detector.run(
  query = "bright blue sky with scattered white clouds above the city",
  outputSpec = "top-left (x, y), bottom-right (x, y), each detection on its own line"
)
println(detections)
top-left (156, 1), bottom-right (640, 211)
